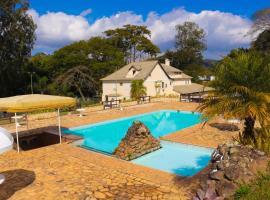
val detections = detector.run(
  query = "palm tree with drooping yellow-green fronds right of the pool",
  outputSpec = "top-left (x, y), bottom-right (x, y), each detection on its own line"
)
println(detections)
top-left (198, 51), bottom-right (270, 143)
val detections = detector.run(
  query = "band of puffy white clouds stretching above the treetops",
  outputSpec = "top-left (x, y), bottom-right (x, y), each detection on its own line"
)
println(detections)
top-left (29, 8), bottom-right (251, 58)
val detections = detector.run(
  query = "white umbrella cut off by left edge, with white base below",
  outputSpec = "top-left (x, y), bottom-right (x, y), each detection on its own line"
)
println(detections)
top-left (0, 127), bottom-right (13, 184)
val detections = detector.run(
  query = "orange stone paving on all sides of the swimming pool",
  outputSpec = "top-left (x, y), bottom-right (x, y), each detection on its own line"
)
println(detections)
top-left (0, 102), bottom-right (238, 200)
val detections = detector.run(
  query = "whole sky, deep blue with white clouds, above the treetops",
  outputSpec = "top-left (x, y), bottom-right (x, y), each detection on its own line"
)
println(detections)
top-left (27, 0), bottom-right (270, 58)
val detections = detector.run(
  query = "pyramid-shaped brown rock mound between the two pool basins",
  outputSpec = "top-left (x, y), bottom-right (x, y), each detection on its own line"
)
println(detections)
top-left (113, 121), bottom-right (161, 160)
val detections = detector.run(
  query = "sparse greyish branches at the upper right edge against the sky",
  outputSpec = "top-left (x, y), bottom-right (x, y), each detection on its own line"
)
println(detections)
top-left (250, 8), bottom-right (270, 34)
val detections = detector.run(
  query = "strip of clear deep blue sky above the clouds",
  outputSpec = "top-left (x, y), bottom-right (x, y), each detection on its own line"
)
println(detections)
top-left (30, 0), bottom-right (270, 19)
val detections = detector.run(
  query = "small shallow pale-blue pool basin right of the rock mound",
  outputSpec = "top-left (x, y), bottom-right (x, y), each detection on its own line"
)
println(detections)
top-left (131, 141), bottom-right (213, 176)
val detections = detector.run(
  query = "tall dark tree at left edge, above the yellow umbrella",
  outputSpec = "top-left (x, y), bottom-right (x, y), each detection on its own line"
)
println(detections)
top-left (0, 0), bottom-right (35, 96)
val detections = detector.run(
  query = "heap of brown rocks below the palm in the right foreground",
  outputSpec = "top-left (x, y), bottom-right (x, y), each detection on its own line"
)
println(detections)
top-left (193, 144), bottom-right (269, 200)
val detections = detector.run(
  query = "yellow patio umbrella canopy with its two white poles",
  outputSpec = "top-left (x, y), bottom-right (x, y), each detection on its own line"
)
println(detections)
top-left (0, 94), bottom-right (76, 152)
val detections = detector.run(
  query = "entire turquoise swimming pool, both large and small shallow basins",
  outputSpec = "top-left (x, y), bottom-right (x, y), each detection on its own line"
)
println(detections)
top-left (64, 110), bottom-right (213, 176)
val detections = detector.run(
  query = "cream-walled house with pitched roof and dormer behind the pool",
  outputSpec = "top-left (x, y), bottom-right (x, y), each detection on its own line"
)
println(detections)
top-left (101, 59), bottom-right (212, 101)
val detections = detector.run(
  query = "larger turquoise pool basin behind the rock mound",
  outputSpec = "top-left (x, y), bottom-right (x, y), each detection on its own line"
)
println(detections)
top-left (64, 110), bottom-right (201, 154)
